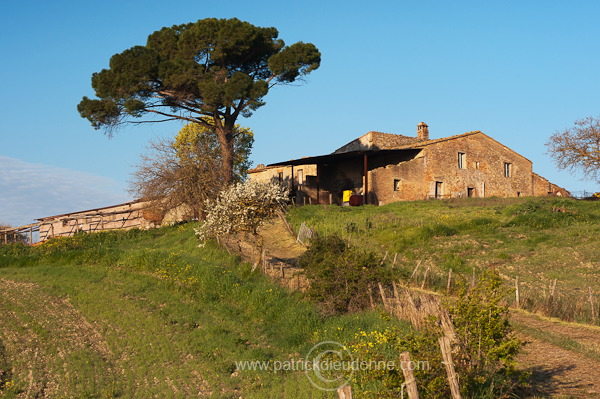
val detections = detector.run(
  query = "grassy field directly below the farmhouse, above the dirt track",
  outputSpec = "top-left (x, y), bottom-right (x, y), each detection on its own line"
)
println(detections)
top-left (288, 198), bottom-right (600, 322)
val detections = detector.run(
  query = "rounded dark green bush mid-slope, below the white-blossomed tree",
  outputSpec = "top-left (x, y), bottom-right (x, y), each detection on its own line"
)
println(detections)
top-left (299, 236), bottom-right (389, 313)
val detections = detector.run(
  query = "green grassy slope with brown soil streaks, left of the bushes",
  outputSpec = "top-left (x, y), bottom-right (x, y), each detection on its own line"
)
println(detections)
top-left (0, 224), bottom-right (405, 398)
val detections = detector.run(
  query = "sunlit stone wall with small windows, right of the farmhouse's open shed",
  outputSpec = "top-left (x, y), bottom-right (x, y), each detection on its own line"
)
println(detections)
top-left (370, 132), bottom-right (534, 204)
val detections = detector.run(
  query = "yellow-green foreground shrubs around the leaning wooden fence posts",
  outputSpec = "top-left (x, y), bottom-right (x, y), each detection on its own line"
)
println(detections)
top-left (348, 271), bottom-right (527, 399)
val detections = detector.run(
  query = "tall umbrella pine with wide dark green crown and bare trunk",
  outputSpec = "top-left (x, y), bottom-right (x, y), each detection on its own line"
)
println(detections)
top-left (77, 18), bottom-right (321, 183)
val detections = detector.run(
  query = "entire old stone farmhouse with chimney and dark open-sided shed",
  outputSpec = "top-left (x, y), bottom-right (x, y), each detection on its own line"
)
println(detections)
top-left (249, 122), bottom-right (570, 205)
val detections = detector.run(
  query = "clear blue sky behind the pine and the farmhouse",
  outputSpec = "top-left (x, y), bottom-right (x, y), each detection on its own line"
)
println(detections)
top-left (0, 0), bottom-right (600, 225)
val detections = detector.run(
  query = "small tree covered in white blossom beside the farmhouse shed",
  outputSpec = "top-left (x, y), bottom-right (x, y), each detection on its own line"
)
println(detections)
top-left (195, 180), bottom-right (289, 267)
